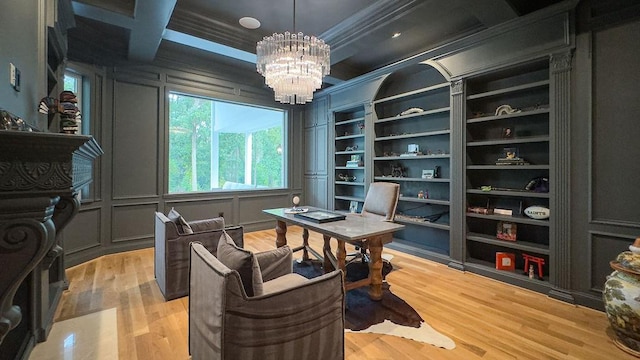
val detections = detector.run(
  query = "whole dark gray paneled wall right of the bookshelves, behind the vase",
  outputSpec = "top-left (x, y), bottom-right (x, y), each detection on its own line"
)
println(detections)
top-left (571, 20), bottom-right (640, 307)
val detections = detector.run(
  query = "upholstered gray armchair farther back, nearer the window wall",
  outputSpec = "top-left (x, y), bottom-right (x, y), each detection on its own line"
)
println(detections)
top-left (154, 209), bottom-right (244, 300)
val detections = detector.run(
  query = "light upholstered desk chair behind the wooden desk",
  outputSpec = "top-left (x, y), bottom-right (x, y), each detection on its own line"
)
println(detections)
top-left (347, 182), bottom-right (400, 263)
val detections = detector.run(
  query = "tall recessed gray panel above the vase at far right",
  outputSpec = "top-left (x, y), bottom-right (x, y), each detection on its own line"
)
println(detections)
top-left (592, 22), bottom-right (640, 228)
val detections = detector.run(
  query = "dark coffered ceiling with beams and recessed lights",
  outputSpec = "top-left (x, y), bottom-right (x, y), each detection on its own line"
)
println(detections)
top-left (68, 0), bottom-right (562, 85)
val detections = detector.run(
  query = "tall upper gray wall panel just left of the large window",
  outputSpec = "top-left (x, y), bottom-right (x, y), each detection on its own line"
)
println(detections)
top-left (113, 82), bottom-right (159, 198)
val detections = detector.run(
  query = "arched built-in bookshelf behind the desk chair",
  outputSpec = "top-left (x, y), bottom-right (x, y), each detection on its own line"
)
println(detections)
top-left (373, 64), bottom-right (451, 258)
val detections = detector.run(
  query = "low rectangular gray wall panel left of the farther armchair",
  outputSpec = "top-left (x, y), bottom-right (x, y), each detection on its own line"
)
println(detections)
top-left (111, 203), bottom-right (158, 243)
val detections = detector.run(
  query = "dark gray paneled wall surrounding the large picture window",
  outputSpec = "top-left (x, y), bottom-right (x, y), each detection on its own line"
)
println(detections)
top-left (63, 53), bottom-right (303, 266)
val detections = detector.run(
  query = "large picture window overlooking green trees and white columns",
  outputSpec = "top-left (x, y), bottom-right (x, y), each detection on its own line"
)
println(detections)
top-left (168, 92), bottom-right (286, 194)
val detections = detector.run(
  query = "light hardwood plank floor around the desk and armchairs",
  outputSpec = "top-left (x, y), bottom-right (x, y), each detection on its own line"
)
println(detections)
top-left (56, 227), bottom-right (624, 360)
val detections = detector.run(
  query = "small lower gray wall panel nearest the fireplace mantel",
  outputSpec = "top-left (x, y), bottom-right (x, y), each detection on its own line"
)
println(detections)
top-left (63, 208), bottom-right (102, 254)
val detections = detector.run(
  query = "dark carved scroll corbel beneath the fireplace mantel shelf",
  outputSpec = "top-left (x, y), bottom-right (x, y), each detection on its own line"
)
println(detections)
top-left (0, 197), bottom-right (59, 343)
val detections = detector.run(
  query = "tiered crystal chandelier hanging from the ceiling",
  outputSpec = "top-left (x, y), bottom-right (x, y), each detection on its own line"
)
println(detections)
top-left (256, 0), bottom-right (330, 104)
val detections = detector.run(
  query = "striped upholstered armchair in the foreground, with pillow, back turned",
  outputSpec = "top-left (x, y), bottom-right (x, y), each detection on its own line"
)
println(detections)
top-left (189, 237), bottom-right (344, 360)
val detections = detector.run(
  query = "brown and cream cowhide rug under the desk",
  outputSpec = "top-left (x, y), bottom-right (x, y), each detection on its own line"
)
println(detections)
top-left (293, 260), bottom-right (455, 350)
